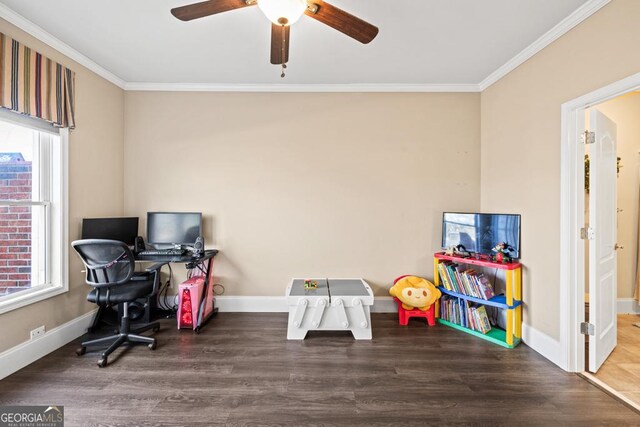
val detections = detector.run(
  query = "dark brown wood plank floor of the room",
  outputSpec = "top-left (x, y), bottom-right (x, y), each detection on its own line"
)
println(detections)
top-left (0, 313), bottom-right (640, 426)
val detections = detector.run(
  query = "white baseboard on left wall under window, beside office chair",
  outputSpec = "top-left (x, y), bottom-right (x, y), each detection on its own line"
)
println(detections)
top-left (0, 309), bottom-right (97, 380)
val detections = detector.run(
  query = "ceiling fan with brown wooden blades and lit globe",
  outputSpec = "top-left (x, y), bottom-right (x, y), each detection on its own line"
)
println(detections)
top-left (171, 0), bottom-right (378, 77)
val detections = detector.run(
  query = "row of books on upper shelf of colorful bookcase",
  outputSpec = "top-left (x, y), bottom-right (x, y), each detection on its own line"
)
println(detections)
top-left (438, 261), bottom-right (495, 300)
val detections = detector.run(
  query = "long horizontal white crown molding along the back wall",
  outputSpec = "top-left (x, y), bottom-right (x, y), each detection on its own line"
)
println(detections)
top-left (124, 83), bottom-right (480, 92)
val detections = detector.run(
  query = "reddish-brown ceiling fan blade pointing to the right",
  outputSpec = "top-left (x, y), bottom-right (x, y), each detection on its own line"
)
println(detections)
top-left (304, 0), bottom-right (378, 44)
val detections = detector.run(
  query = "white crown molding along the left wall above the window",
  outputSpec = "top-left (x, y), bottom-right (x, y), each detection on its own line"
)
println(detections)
top-left (0, 3), bottom-right (126, 89)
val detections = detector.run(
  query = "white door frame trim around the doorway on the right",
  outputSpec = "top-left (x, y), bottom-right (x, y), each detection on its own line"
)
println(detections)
top-left (558, 73), bottom-right (640, 372)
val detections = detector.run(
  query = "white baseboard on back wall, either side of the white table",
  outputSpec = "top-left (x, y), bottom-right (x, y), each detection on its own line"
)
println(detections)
top-left (210, 295), bottom-right (398, 313)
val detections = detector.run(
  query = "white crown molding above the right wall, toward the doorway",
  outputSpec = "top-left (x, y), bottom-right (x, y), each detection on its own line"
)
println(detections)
top-left (478, 0), bottom-right (611, 92)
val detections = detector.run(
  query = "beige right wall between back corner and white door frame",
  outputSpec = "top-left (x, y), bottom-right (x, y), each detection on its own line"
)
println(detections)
top-left (481, 0), bottom-right (640, 339)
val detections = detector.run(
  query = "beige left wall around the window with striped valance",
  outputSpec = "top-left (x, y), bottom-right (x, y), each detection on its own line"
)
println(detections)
top-left (0, 19), bottom-right (124, 352)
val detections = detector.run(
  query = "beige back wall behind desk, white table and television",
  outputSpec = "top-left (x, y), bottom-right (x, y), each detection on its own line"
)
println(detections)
top-left (125, 92), bottom-right (480, 296)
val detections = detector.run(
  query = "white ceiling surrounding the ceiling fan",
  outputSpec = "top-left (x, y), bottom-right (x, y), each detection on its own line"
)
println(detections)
top-left (0, 0), bottom-right (587, 85)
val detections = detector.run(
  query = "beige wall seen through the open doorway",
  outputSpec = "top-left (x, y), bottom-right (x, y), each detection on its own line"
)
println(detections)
top-left (595, 92), bottom-right (640, 298)
